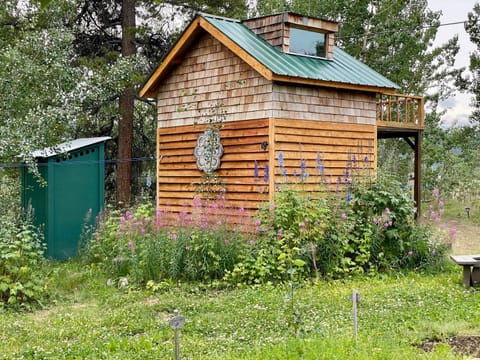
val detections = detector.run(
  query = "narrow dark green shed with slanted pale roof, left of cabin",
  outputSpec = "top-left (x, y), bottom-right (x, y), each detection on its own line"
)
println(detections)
top-left (21, 137), bottom-right (110, 260)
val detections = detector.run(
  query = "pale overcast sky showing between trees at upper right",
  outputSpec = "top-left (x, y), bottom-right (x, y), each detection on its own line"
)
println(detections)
top-left (428, 0), bottom-right (480, 124)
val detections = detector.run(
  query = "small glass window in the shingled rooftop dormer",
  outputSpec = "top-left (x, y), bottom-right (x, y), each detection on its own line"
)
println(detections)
top-left (289, 27), bottom-right (327, 58)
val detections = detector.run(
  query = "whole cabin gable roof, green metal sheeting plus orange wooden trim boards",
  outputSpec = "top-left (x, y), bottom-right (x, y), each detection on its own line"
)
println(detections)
top-left (140, 14), bottom-right (399, 97)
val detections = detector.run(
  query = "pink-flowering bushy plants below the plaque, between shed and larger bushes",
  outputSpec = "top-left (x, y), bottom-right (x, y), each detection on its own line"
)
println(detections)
top-left (82, 198), bottom-right (245, 286)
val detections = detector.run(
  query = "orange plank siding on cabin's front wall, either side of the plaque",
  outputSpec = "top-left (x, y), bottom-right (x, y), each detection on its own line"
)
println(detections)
top-left (157, 119), bottom-right (268, 216)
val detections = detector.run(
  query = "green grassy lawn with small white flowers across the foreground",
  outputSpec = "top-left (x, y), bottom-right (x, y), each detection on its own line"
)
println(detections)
top-left (0, 263), bottom-right (480, 359)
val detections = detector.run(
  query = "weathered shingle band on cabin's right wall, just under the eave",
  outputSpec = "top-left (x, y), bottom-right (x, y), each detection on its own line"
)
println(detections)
top-left (272, 83), bottom-right (376, 125)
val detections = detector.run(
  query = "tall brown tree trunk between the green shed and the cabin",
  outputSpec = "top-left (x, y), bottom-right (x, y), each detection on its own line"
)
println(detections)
top-left (117, 0), bottom-right (137, 207)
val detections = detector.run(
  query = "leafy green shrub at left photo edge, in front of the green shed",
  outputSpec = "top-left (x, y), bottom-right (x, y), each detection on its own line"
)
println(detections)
top-left (0, 211), bottom-right (45, 309)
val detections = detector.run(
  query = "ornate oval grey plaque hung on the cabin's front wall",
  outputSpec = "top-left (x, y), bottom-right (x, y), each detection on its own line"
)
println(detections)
top-left (193, 128), bottom-right (223, 174)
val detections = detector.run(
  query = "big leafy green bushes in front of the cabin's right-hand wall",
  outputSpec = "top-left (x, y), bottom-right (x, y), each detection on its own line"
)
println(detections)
top-left (225, 170), bottom-right (447, 284)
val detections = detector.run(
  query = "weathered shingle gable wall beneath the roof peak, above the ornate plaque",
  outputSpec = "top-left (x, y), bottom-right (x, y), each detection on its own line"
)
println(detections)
top-left (158, 34), bottom-right (272, 127)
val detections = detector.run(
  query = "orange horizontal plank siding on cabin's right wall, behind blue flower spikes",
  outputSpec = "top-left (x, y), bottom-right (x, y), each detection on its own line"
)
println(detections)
top-left (274, 119), bottom-right (376, 191)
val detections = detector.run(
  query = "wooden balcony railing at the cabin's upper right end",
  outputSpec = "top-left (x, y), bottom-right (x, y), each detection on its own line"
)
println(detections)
top-left (377, 94), bottom-right (424, 130)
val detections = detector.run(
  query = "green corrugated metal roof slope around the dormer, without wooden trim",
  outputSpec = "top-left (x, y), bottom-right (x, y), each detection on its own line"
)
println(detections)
top-left (200, 14), bottom-right (400, 89)
